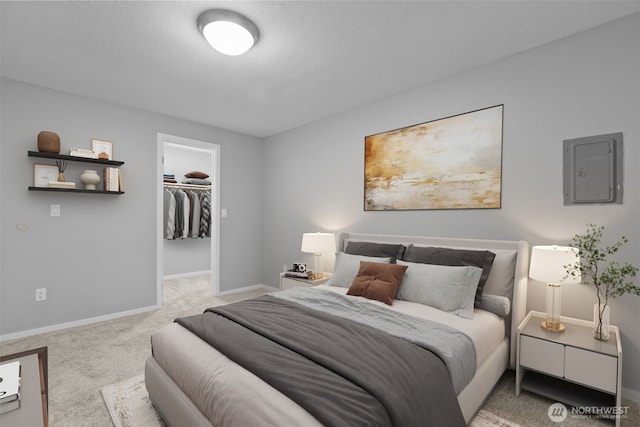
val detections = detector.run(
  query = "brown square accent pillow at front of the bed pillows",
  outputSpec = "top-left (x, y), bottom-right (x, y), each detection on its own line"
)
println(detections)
top-left (347, 261), bottom-right (407, 305)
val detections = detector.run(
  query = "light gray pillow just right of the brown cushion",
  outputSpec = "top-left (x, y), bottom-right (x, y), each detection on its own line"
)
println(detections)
top-left (396, 260), bottom-right (482, 319)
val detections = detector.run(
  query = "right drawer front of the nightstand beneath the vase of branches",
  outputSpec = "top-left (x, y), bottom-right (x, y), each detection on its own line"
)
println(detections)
top-left (564, 346), bottom-right (618, 394)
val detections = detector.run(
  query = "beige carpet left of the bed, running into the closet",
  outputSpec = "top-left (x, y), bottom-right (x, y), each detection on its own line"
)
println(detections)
top-left (0, 276), bottom-right (266, 427)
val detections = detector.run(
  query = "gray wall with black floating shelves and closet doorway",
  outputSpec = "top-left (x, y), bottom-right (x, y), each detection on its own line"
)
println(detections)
top-left (0, 79), bottom-right (263, 335)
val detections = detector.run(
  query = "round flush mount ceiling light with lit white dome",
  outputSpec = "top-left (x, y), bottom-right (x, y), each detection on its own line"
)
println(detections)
top-left (198, 9), bottom-right (258, 56)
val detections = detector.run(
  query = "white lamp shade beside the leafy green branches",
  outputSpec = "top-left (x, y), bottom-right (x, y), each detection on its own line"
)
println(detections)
top-left (529, 245), bottom-right (581, 284)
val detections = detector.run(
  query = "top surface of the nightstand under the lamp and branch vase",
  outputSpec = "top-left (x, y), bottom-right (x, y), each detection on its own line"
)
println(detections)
top-left (521, 313), bottom-right (618, 357)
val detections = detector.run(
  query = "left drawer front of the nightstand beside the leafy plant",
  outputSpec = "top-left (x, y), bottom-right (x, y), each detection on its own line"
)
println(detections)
top-left (520, 335), bottom-right (564, 377)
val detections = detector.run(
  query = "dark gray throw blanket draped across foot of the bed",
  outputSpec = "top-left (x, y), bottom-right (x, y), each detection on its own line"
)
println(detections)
top-left (176, 295), bottom-right (466, 427)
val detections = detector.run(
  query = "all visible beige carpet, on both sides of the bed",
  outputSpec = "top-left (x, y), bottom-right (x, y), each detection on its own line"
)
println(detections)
top-left (0, 276), bottom-right (640, 427)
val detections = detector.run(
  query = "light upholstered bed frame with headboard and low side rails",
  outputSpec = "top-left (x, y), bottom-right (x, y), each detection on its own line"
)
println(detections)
top-left (145, 233), bottom-right (529, 427)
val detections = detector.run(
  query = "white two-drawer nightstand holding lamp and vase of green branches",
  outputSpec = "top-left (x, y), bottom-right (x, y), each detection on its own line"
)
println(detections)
top-left (516, 311), bottom-right (622, 426)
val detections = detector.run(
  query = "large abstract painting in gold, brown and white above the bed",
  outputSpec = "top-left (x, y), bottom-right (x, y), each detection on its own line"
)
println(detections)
top-left (364, 105), bottom-right (504, 211)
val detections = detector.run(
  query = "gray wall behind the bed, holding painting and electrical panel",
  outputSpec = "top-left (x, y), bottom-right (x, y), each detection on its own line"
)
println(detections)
top-left (264, 14), bottom-right (640, 399)
